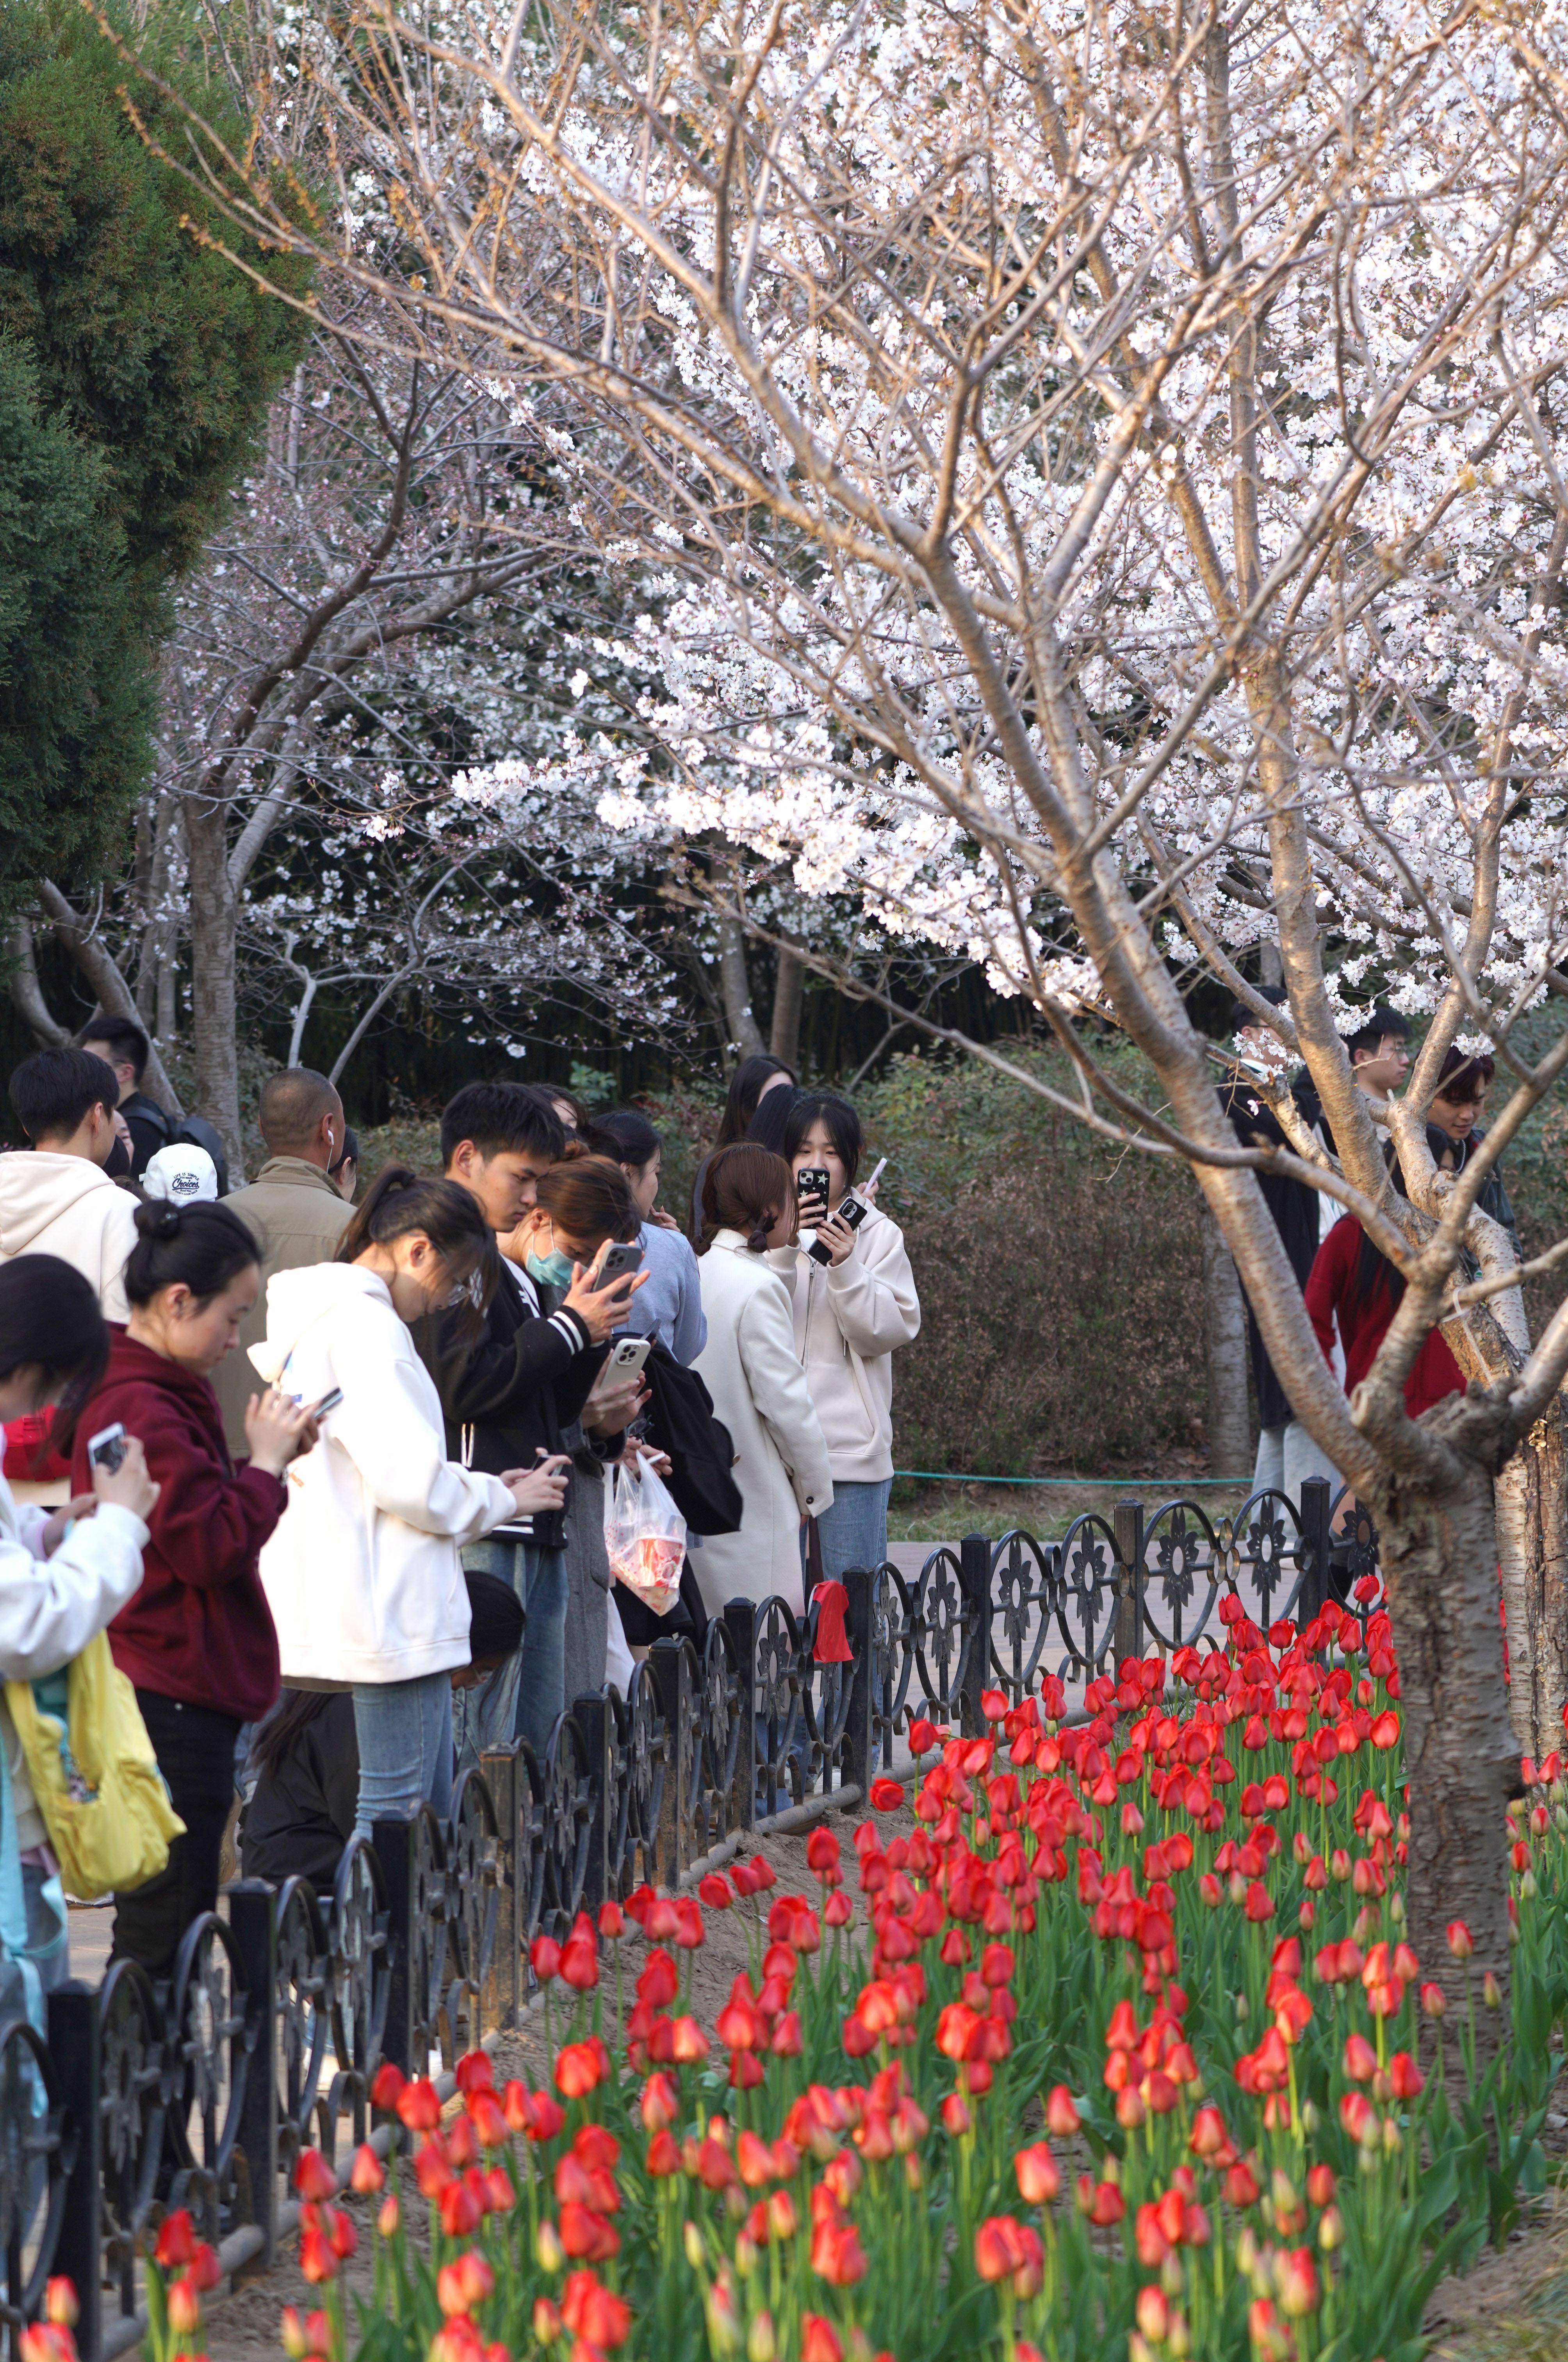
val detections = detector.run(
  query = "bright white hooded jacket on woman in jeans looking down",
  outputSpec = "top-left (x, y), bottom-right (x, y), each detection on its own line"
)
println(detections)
top-left (250, 1264), bottom-right (517, 1689)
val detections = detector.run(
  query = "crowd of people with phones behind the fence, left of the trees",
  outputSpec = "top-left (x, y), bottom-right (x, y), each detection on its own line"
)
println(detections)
top-left (0, 1018), bottom-right (921, 1986)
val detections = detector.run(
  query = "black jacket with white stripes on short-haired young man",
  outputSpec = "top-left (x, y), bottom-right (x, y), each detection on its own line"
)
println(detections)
top-left (415, 1261), bottom-right (609, 1549)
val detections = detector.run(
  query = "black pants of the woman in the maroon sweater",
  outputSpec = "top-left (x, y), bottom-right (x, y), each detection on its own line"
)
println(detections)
top-left (111, 1689), bottom-right (241, 1977)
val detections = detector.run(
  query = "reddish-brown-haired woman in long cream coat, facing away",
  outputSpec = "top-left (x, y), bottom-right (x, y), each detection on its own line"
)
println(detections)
top-left (694, 1141), bottom-right (834, 1616)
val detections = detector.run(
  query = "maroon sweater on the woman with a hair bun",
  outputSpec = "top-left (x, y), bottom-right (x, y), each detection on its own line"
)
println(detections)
top-left (71, 1327), bottom-right (288, 1722)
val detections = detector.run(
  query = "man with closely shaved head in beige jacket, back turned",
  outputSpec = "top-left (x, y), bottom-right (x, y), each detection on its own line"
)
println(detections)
top-left (212, 1065), bottom-right (354, 1458)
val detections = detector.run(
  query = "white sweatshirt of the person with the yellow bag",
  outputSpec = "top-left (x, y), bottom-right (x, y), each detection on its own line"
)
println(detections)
top-left (0, 1474), bottom-right (146, 1854)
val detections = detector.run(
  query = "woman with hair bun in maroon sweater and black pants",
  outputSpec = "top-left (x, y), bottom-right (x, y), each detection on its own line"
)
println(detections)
top-left (71, 1200), bottom-right (316, 1977)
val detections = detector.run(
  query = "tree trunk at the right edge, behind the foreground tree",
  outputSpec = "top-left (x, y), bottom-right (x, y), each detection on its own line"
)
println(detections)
top-left (1495, 1393), bottom-right (1568, 1762)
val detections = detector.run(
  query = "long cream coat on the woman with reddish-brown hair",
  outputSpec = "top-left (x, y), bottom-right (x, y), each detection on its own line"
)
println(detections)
top-left (692, 1231), bottom-right (834, 1616)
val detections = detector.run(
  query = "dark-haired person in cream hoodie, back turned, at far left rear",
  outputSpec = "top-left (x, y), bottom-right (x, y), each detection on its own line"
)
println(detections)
top-left (0, 1049), bottom-right (137, 1320)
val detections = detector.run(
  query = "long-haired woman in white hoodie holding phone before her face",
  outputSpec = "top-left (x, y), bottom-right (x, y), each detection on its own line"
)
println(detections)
top-left (770, 1091), bottom-right (921, 1580)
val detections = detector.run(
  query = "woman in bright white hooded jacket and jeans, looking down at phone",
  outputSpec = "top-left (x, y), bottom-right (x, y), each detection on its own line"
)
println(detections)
top-left (250, 1165), bottom-right (567, 1830)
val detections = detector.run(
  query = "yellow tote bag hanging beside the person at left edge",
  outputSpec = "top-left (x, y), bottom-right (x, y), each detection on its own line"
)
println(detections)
top-left (5, 1632), bottom-right (184, 1902)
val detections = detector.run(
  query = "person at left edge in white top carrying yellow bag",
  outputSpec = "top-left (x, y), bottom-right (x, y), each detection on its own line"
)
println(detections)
top-left (0, 1254), bottom-right (158, 1991)
